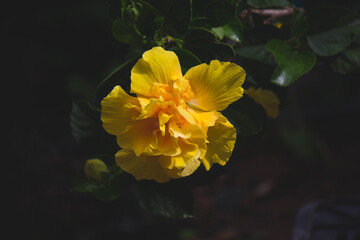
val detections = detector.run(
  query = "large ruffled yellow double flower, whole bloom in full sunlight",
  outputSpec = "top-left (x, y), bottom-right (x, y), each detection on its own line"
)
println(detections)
top-left (101, 47), bottom-right (245, 182)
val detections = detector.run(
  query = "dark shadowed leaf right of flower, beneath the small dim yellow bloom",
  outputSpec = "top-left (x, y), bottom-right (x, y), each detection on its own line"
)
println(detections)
top-left (222, 95), bottom-right (263, 135)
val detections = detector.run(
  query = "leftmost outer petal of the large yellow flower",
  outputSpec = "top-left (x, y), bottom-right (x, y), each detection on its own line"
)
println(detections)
top-left (101, 86), bottom-right (141, 135)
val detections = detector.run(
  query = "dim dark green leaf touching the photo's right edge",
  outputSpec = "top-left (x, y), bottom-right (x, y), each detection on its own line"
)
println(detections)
top-left (308, 24), bottom-right (360, 57)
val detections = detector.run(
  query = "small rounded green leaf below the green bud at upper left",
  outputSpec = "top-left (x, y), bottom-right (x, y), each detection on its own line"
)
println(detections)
top-left (111, 19), bottom-right (137, 43)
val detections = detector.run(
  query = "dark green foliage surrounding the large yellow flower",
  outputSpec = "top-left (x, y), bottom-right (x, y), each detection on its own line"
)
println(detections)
top-left (71, 0), bottom-right (360, 217)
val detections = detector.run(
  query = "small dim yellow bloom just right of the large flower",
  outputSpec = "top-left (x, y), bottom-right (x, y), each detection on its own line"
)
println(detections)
top-left (245, 87), bottom-right (280, 118)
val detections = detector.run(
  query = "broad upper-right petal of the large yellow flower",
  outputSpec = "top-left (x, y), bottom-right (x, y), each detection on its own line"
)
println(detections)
top-left (185, 60), bottom-right (245, 111)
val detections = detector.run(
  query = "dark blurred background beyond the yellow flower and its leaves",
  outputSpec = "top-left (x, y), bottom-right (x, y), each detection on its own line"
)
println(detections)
top-left (2, 0), bottom-right (360, 240)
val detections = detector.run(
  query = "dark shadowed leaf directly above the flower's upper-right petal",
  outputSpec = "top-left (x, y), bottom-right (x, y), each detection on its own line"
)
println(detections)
top-left (183, 28), bottom-right (235, 61)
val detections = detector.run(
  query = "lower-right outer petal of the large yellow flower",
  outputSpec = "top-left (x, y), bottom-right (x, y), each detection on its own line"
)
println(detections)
top-left (201, 115), bottom-right (236, 170)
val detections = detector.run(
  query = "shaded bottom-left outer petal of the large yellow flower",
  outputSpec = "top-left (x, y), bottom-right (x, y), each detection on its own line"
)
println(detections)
top-left (115, 149), bottom-right (170, 183)
